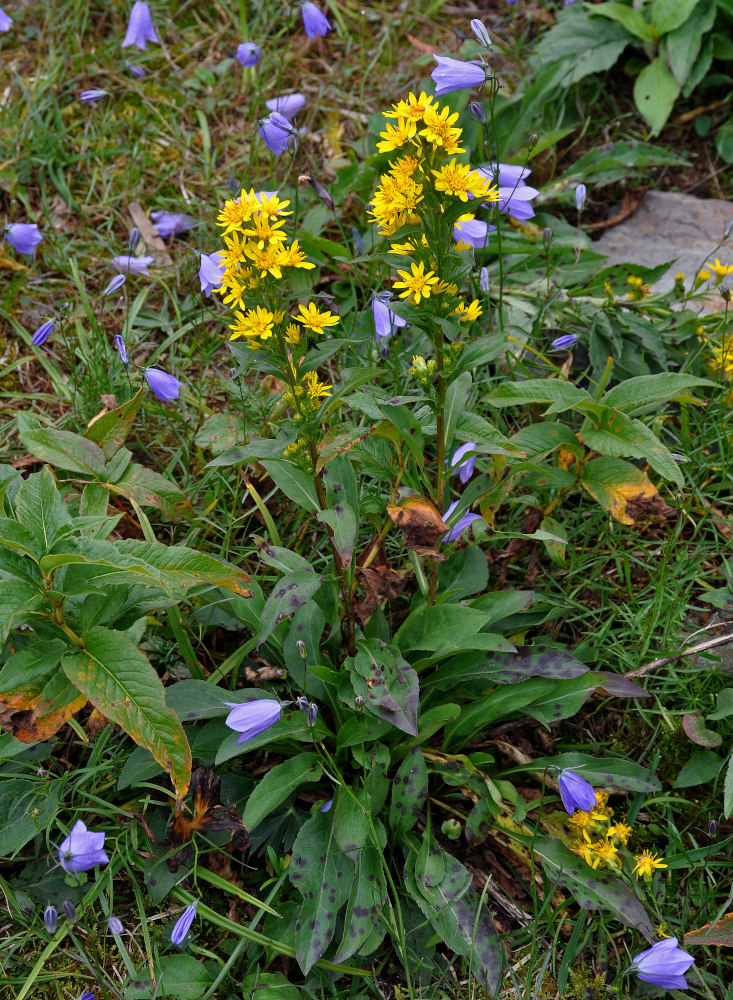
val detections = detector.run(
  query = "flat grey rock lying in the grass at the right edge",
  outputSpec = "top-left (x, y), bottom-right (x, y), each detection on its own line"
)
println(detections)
top-left (593, 191), bottom-right (733, 292)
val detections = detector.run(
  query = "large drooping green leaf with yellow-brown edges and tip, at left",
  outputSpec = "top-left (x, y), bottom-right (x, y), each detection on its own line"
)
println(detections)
top-left (61, 626), bottom-right (191, 799)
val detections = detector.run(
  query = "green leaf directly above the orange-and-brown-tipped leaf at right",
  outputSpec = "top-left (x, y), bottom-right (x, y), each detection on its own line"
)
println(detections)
top-left (580, 404), bottom-right (684, 486)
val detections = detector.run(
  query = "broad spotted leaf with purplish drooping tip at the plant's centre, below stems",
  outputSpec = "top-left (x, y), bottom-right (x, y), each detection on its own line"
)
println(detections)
top-left (346, 639), bottom-right (420, 736)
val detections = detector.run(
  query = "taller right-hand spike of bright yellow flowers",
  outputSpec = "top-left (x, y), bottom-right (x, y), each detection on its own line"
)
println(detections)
top-left (369, 92), bottom-right (499, 340)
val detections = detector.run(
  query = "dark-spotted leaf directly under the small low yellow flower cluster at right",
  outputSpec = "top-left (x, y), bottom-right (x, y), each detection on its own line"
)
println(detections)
top-left (532, 837), bottom-right (654, 941)
